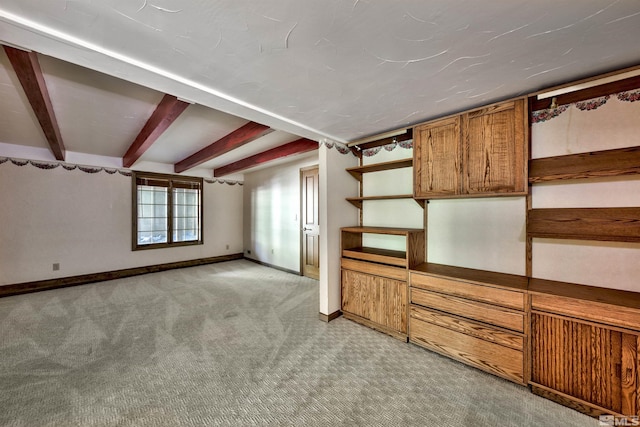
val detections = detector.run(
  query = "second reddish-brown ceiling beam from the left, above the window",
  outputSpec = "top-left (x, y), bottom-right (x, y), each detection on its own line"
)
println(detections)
top-left (122, 95), bottom-right (189, 168)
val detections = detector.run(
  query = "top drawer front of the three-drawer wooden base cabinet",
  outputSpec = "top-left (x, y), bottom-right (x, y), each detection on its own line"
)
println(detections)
top-left (411, 272), bottom-right (525, 311)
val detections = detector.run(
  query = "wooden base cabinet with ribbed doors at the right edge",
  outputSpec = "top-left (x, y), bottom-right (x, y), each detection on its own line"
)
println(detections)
top-left (529, 279), bottom-right (640, 416)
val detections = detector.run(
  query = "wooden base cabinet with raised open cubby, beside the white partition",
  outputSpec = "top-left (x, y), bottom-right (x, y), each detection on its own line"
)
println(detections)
top-left (341, 227), bottom-right (425, 341)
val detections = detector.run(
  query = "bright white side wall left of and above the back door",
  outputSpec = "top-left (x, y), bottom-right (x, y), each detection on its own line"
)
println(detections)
top-left (243, 154), bottom-right (322, 273)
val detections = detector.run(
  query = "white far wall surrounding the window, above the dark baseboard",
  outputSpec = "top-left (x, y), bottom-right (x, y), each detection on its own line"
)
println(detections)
top-left (0, 153), bottom-right (243, 285)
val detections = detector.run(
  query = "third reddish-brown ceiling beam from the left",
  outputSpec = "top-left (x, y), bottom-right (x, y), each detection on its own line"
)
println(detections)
top-left (173, 122), bottom-right (273, 173)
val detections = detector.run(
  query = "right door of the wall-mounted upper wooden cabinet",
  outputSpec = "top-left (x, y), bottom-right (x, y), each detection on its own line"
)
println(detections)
top-left (462, 99), bottom-right (527, 195)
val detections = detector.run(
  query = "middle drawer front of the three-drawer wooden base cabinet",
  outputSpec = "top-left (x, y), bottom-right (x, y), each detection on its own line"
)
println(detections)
top-left (411, 305), bottom-right (524, 351)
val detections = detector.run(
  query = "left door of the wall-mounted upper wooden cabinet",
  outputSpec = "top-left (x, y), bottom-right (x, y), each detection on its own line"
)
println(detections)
top-left (413, 116), bottom-right (461, 198)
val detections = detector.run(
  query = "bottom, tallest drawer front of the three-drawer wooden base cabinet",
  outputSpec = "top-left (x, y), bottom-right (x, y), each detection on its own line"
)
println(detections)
top-left (409, 318), bottom-right (525, 384)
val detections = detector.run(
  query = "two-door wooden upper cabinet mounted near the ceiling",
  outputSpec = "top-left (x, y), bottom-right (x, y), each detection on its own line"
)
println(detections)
top-left (413, 99), bottom-right (528, 199)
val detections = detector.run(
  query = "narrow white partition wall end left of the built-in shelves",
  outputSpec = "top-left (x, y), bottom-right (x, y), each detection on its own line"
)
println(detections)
top-left (320, 144), bottom-right (358, 315)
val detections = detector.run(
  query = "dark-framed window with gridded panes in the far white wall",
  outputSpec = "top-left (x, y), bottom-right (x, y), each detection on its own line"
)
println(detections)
top-left (132, 172), bottom-right (203, 250)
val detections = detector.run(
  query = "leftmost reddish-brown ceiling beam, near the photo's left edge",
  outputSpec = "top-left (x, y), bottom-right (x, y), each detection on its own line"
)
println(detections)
top-left (2, 46), bottom-right (66, 161)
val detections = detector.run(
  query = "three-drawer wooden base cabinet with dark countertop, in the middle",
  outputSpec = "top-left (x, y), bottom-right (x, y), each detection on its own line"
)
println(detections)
top-left (409, 264), bottom-right (528, 385)
